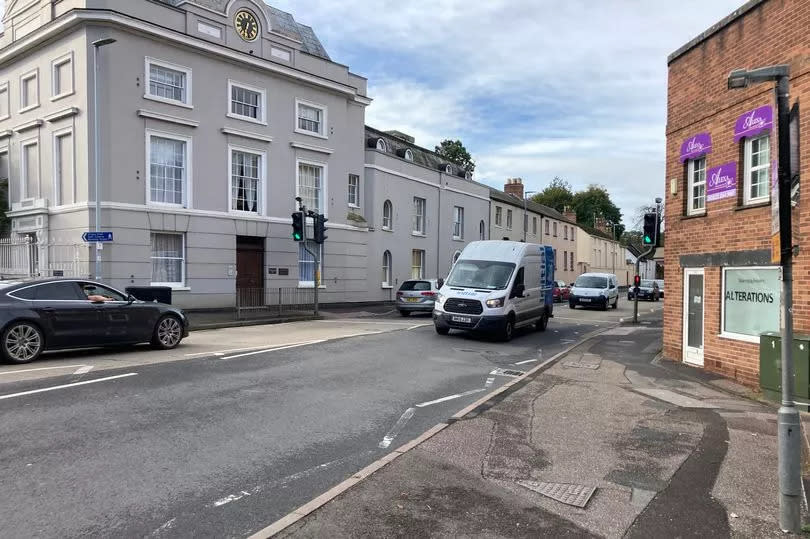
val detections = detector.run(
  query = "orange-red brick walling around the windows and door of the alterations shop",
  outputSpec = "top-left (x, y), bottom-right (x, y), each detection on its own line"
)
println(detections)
top-left (664, 0), bottom-right (810, 386)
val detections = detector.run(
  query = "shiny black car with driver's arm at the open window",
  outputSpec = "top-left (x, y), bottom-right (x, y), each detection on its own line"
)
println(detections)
top-left (0, 279), bottom-right (188, 363)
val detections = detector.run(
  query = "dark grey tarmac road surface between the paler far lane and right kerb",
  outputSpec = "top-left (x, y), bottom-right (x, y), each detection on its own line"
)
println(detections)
top-left (0, 302), bottom-right (662, 537)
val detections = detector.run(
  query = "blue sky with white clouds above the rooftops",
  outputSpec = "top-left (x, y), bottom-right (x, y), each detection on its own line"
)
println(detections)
top-left (270, 0), bottom-right (744, 226)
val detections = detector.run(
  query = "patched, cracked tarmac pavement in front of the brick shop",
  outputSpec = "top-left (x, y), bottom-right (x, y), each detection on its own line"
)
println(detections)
top-left (268, 316), bottom-right (806, 538)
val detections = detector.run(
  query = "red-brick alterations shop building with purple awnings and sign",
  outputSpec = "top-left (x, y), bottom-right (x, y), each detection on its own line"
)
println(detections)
top-left (664, 0), bottom-right (810, 386)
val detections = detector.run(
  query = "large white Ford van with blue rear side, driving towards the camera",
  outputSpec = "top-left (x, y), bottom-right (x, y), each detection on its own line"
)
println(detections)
top-left (433, 241), bottom-right (554, 341)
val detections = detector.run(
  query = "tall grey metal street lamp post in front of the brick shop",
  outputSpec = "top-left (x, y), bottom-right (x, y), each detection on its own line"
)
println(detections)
top-left (728, 64), bottom-right (802, 533)
